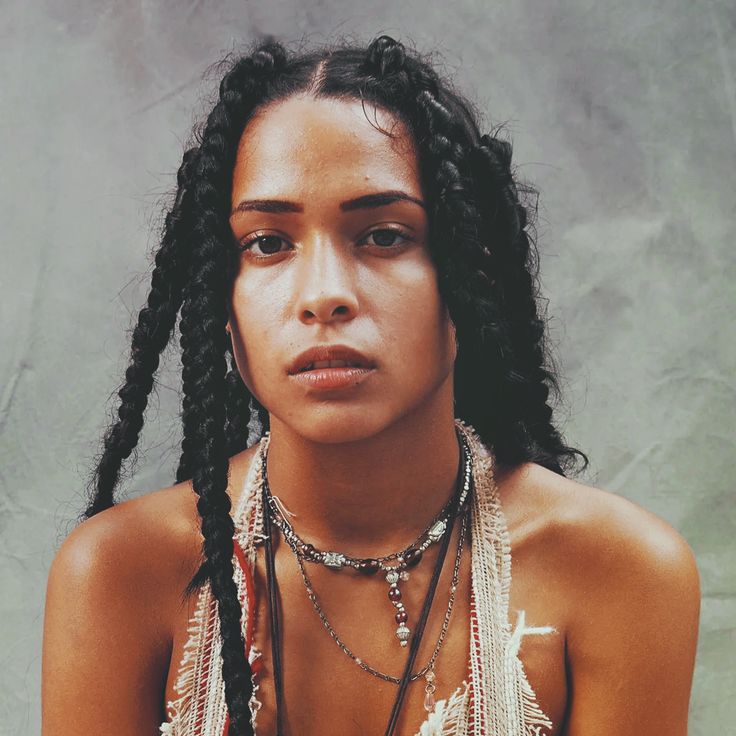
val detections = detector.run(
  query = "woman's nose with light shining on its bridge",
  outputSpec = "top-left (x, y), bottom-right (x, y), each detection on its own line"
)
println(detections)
top-left (296, 236), bottom-right (358, 324)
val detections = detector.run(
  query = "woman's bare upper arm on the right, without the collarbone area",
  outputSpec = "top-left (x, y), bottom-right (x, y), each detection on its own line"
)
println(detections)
top-left (565, 494), bottom-right (700, 736)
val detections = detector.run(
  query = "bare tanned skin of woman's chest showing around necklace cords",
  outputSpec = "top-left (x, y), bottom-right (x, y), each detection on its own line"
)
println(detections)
top-left (165, 520), bottom-right (568, 736)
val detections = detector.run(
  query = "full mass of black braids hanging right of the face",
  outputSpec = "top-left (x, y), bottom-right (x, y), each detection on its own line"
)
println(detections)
top-left (367, 36), bottom-right (575, 472)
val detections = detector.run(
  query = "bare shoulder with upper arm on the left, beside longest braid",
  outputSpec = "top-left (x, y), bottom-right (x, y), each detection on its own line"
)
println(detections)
top-left (42, 484), bottom-right (204, 736)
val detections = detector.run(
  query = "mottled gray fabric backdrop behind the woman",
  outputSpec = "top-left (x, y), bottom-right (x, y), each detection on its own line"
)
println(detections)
top-left (0, 0), bottom-right (736, 736)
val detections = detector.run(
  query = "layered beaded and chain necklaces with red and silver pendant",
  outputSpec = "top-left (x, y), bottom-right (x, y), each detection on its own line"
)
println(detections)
top-left (261, 428), bottom-right (473, 723)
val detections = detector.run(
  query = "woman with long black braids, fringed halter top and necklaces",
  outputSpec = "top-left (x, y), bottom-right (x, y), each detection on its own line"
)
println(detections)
top-left (43, 36), bottom-right (699, 736)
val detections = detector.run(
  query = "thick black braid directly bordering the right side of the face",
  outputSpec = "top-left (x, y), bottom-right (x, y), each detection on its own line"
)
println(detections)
top-left (386, 46), bottom-right (511, 446)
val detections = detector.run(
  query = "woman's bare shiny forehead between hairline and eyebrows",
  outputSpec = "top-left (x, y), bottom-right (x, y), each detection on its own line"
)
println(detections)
top-left (233, 96), bottom-right (421, 205)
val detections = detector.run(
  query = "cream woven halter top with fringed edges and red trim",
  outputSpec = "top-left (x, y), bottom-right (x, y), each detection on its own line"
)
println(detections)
top-left (160, 419), bottom-right (554, 736)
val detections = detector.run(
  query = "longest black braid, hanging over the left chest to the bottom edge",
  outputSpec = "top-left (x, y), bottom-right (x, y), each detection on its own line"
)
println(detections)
top-left (181, 45), bottom-right (285, 735)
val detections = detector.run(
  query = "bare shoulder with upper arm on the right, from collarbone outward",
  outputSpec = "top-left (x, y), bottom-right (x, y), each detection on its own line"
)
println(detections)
top-left (499, 464), bottom-right (700, 736)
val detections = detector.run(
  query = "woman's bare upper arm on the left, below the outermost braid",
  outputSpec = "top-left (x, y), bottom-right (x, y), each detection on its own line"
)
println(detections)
top-left (42, 504), bottom-right (178, 736)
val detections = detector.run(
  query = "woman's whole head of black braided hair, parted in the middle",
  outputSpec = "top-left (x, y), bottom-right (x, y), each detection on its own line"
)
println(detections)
top-left (85, 36), bottom-right (587, 735)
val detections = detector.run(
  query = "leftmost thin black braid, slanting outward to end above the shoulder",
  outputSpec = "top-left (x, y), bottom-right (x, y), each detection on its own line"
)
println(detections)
top-left (84, 149), bottom-right (197, 518)
